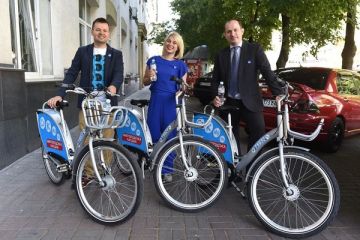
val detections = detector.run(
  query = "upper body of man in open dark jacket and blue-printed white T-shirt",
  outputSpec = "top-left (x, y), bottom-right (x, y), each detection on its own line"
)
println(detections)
top-left (48, 18), bottom-right (124, 107)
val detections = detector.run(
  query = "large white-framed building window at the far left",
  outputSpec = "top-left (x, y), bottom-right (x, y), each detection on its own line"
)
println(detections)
top-left (10, 0), bottom-right (53, 75)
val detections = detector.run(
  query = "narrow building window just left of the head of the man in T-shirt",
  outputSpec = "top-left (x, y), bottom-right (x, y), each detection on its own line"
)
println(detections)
top-left (79, 0), bottom-right (91, 46)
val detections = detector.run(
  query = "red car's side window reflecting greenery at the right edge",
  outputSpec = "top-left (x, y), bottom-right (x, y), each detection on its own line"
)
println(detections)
top-left (336, 74), bottom-right (360, 95)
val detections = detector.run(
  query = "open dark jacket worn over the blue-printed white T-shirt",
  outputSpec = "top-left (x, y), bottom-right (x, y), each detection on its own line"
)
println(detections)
top-left (58, 44), bottom-right (124, 107)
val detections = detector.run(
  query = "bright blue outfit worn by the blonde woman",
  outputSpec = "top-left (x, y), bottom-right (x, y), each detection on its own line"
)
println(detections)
top-left (146, 56), bottom-right (187, 173)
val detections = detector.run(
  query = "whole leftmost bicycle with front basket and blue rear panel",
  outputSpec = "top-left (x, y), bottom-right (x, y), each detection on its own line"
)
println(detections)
top-left (36, 87), bottom-right (143, 224)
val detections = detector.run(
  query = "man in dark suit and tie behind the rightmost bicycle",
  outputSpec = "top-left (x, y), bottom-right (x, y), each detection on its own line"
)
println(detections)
top-left (212, 20), bottom-right (282, 153)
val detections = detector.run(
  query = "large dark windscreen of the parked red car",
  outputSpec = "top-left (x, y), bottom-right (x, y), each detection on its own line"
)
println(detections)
top-left (277, 68), bottom-right (330, 90)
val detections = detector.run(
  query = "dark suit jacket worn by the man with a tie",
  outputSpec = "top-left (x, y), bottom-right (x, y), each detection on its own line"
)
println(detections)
top-left (212, 41), bottom-right (282, 112)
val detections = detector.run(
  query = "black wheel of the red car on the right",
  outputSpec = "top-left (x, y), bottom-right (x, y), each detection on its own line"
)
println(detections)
top-left (325, 117), bottom-right (345, 153)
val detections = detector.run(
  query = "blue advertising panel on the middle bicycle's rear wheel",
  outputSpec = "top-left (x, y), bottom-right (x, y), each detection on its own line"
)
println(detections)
top-left (116, 111), bottom-right (148, 152)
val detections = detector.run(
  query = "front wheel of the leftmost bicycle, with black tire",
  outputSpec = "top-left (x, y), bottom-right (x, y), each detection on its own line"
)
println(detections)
top-left (73, 141), bottom-right (144, 225)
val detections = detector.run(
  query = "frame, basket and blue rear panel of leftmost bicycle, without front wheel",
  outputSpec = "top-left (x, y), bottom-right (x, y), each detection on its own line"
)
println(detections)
top-left (36, 88), bottom-right (127, 184)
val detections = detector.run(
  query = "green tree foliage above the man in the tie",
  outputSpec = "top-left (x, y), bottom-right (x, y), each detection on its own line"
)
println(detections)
top-left (150, 0), bottom-right (359, 67)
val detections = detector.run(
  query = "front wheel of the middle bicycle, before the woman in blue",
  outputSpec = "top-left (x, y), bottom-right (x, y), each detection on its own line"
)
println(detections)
top-left (153, 136), bottom-right (228, 212)
